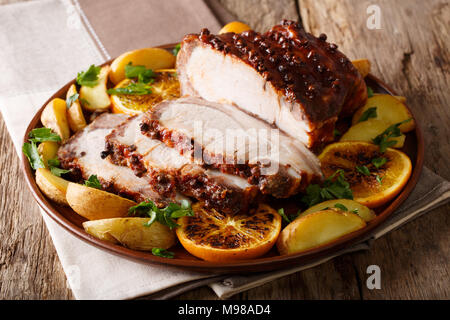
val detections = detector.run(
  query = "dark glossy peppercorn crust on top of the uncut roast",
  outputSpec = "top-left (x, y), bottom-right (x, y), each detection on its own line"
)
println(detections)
top-left (182, 20), bottom-right (367, 126)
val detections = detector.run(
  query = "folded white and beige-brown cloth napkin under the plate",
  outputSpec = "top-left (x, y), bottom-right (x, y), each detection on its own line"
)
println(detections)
top-left (0, 0), bottom-right (450, 299)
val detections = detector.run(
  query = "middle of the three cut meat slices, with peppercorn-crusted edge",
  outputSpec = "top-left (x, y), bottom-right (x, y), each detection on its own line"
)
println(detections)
top-left (105, 115), bottom-right (259, 214)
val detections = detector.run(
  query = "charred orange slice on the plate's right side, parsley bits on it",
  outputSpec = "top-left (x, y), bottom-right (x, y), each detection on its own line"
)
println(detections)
top-left (319, 141), bottom-right (412, 208)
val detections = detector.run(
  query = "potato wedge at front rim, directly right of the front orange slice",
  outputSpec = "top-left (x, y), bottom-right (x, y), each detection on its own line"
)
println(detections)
top-left (277, 209), bottom-right (366, 254)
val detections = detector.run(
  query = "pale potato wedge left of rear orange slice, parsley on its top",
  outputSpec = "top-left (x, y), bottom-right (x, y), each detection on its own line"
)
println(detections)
top-left (79, 66), bottom-right (111, 112)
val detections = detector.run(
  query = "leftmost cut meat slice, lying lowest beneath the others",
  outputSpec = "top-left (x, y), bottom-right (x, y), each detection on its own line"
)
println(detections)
top-left (58, 113), bottom-right (183, 206)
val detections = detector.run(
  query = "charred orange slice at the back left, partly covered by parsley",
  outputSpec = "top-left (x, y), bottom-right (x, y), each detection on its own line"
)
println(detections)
top-left (111, 69), bottom-right (180, 115)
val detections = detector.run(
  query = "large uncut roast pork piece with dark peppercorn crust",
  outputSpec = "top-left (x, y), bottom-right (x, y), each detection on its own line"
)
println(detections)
top-left (177, 21), bottom-right (367, 148)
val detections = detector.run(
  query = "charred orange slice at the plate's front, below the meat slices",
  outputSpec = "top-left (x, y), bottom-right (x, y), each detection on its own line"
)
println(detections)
top-left (176, 203), bottom-right (281, 262)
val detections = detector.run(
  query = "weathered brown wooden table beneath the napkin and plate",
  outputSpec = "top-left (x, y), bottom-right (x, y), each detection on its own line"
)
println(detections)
top-left (0, 0), bottom-right (450, 299)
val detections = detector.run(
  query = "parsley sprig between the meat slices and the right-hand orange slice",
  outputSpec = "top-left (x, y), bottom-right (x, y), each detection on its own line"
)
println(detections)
top-left (301, 169), bottom-right (353, 208)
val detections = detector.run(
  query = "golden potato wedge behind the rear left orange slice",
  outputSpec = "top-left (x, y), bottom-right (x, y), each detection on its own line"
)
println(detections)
top-left (109, 48), bottom-right (176, 85)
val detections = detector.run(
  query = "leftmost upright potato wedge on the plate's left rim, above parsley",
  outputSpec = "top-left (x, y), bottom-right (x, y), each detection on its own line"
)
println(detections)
top-left (41, 98), bottom-right (70, 142)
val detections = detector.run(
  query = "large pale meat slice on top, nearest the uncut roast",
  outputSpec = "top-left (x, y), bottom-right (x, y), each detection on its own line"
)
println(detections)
top-left (141, 97), bottom-right (322, 198)
